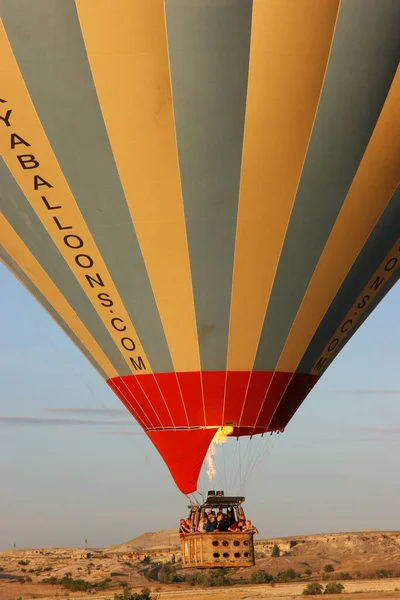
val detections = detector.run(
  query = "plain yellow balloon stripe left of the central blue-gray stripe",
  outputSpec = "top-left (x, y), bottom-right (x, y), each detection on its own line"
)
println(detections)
top-left (76, 0), bottom-right (200, 371)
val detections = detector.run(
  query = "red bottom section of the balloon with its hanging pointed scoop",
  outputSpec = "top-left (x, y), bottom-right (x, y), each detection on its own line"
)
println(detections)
top-left (108, 371), bottom-right (318, 494)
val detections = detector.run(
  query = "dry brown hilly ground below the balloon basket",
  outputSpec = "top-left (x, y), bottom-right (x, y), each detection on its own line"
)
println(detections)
top-left (0, 530), bottom-right (400, 600)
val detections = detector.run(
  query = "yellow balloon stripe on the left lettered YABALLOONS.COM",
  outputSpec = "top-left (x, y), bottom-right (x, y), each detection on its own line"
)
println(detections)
top-left (0, 23), bottom-right (151, 374)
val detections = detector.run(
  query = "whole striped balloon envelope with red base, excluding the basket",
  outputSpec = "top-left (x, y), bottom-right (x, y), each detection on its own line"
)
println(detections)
top-left (0, 0), bottom-right (400, 502)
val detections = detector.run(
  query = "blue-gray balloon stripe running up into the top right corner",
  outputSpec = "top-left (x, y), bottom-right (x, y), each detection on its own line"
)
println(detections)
top-left (254, 0), bottom-right (400, 371)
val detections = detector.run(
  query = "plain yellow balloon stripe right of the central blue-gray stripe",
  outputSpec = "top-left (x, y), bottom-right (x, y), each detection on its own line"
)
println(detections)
top-left (228, 0), bottom-right (339, 370)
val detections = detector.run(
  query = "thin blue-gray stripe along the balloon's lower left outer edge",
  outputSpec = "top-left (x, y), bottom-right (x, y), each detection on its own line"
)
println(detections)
top-left (0, 245), bottom-right (108, 380)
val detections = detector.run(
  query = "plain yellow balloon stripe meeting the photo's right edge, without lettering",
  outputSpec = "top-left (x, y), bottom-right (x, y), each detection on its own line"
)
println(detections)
top-left (277, 67), bottom-right (400, 371)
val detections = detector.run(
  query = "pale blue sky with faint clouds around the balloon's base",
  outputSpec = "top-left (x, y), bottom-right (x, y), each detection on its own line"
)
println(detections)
top-left (0, 265), bottom-right (400, 550)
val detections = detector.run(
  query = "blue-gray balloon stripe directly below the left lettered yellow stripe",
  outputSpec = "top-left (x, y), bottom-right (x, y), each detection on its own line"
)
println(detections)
top-left (0, 158), bottom-right (131, 375)
